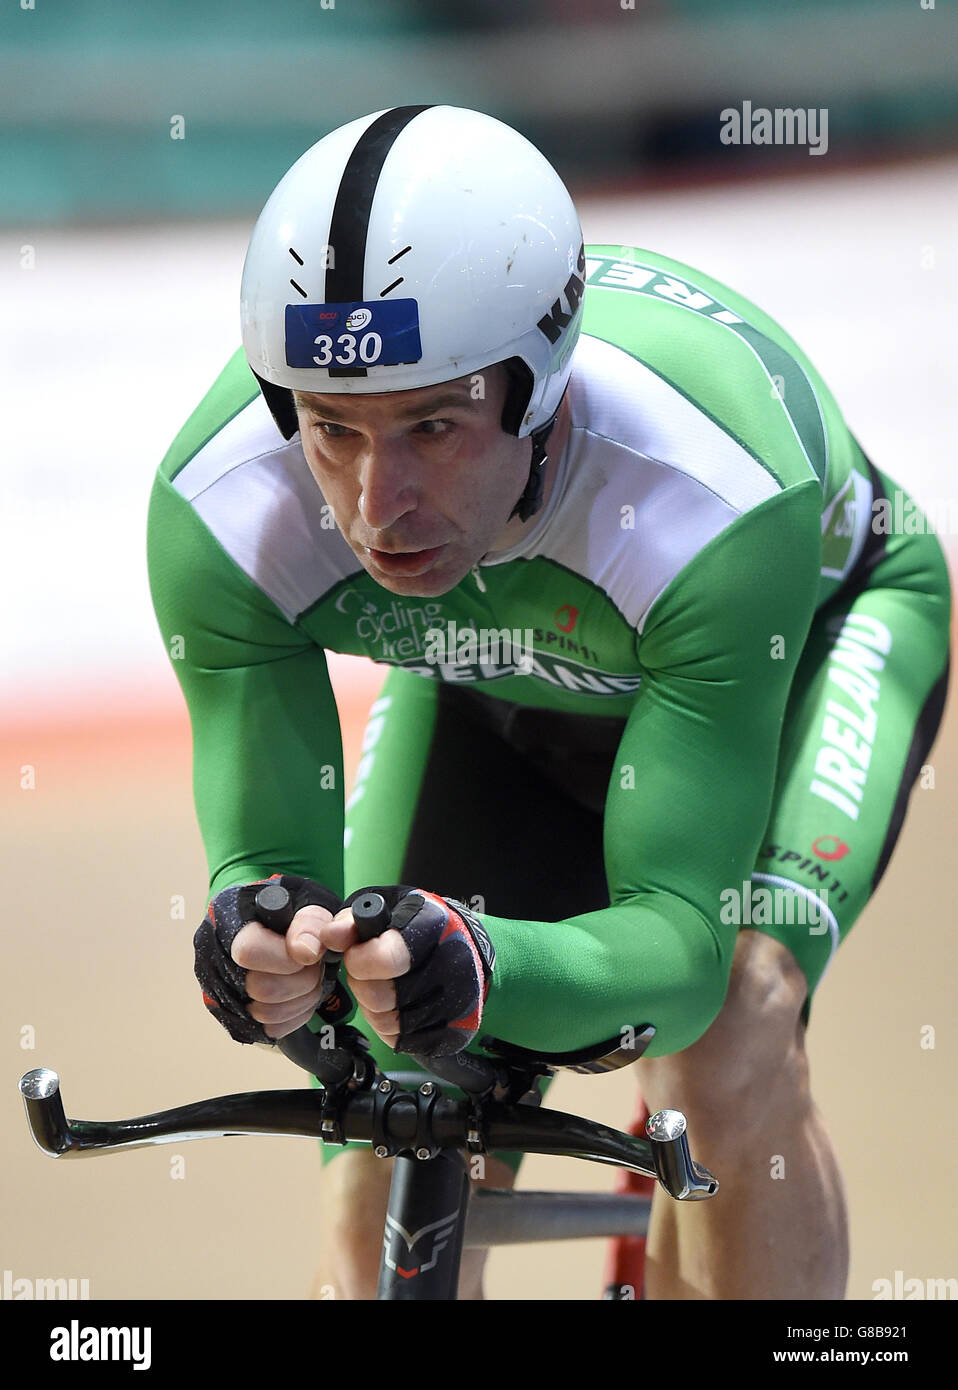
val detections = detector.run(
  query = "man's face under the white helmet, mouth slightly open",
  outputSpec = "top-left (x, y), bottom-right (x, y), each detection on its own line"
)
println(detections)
top-left (293, 366), bottom-right (531, 598)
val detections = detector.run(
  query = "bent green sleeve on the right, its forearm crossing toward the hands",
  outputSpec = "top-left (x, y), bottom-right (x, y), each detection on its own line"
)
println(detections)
top-left (482, 480), bottom-right (820, 1056)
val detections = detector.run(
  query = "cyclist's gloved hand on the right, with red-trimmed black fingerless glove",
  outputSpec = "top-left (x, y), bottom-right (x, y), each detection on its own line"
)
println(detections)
top-left (321, 885), bottom-right (495, 1056)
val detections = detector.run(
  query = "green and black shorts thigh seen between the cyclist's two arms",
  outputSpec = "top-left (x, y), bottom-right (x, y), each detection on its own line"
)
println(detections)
top-left (345, 669), bottom-right (608, 920)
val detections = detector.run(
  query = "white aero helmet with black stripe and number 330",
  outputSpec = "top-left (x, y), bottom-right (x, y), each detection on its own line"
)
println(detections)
top-left (242, 106), bottom-right (585, 508)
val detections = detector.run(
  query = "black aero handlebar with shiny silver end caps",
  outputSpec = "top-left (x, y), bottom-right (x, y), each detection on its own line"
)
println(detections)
top-left (19, 883), bottom-right (719, 1201)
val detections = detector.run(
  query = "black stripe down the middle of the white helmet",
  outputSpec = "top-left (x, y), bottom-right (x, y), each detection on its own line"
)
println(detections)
top-left (325, 106), bottom-right (430, 377)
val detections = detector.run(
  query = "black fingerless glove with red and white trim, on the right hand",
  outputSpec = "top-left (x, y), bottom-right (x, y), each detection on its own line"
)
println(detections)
top-left (343, 884), bottom-right (495, 1056)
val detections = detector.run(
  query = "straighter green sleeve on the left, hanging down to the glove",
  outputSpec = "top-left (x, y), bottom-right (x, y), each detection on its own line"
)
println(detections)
top-left (147, 474), bottom-right (343, 895)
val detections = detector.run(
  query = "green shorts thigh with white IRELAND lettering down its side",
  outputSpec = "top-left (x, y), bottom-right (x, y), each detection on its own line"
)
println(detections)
top-left (744, 461), bottom-right (950, 1022)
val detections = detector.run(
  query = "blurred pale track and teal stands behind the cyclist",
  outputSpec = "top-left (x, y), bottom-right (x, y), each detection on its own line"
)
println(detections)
top-left (0, 0), bottom-right (958, 1300)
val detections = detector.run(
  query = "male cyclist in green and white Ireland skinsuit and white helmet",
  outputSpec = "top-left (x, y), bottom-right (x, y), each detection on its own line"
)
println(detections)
top-left (149, 106), bottom-right (950, 1298)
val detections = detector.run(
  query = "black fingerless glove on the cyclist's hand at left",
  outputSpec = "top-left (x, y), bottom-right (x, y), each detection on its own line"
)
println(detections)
top-left (193, 874), bottom-right (343, 1045)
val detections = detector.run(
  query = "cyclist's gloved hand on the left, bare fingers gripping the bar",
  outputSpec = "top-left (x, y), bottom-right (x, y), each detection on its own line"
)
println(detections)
top-left (193, 874), bottom-right (341, 1043)
